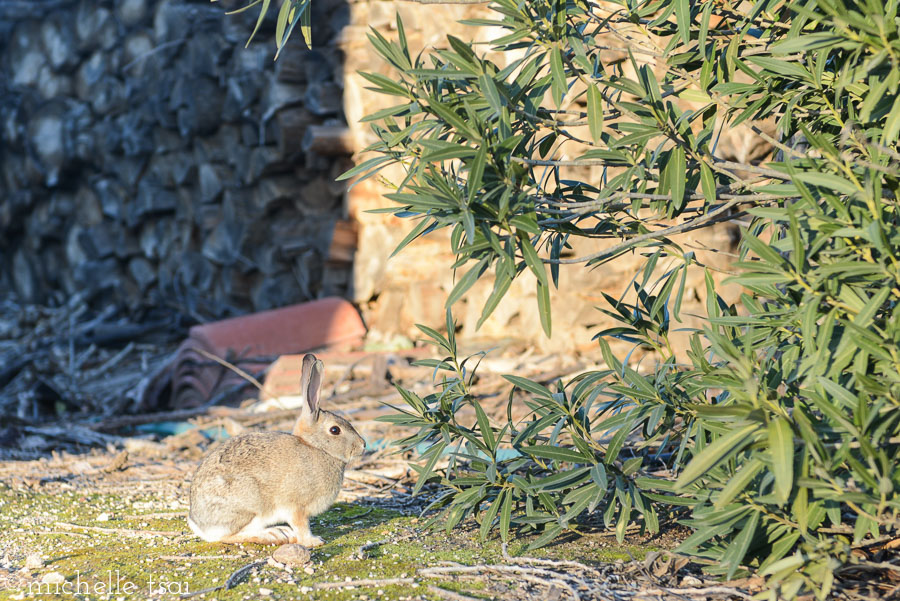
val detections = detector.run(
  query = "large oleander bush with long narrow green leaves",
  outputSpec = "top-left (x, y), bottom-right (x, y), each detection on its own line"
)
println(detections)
top-left (253, 0), bottom-right (900, 599)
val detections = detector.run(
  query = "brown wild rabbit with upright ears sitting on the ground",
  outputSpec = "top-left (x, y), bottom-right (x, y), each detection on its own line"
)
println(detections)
top-left (188, 354), bottom-right (365, 547)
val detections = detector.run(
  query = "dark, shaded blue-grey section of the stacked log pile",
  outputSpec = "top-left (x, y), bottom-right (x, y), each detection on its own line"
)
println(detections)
top-left (0, 0), bottom-right (352, 320)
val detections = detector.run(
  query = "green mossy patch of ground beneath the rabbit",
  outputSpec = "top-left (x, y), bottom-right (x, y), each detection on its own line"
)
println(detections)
top-left (0, 484), bottom-right (650, 601)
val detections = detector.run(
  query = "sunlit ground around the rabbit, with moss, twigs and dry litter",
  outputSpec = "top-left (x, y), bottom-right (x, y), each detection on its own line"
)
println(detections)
top-left (0, 357), bottom-right (759, 601)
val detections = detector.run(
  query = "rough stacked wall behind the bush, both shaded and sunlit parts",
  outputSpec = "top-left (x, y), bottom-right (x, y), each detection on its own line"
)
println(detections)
top-left (0, 0), bottom-right (757, 349)
